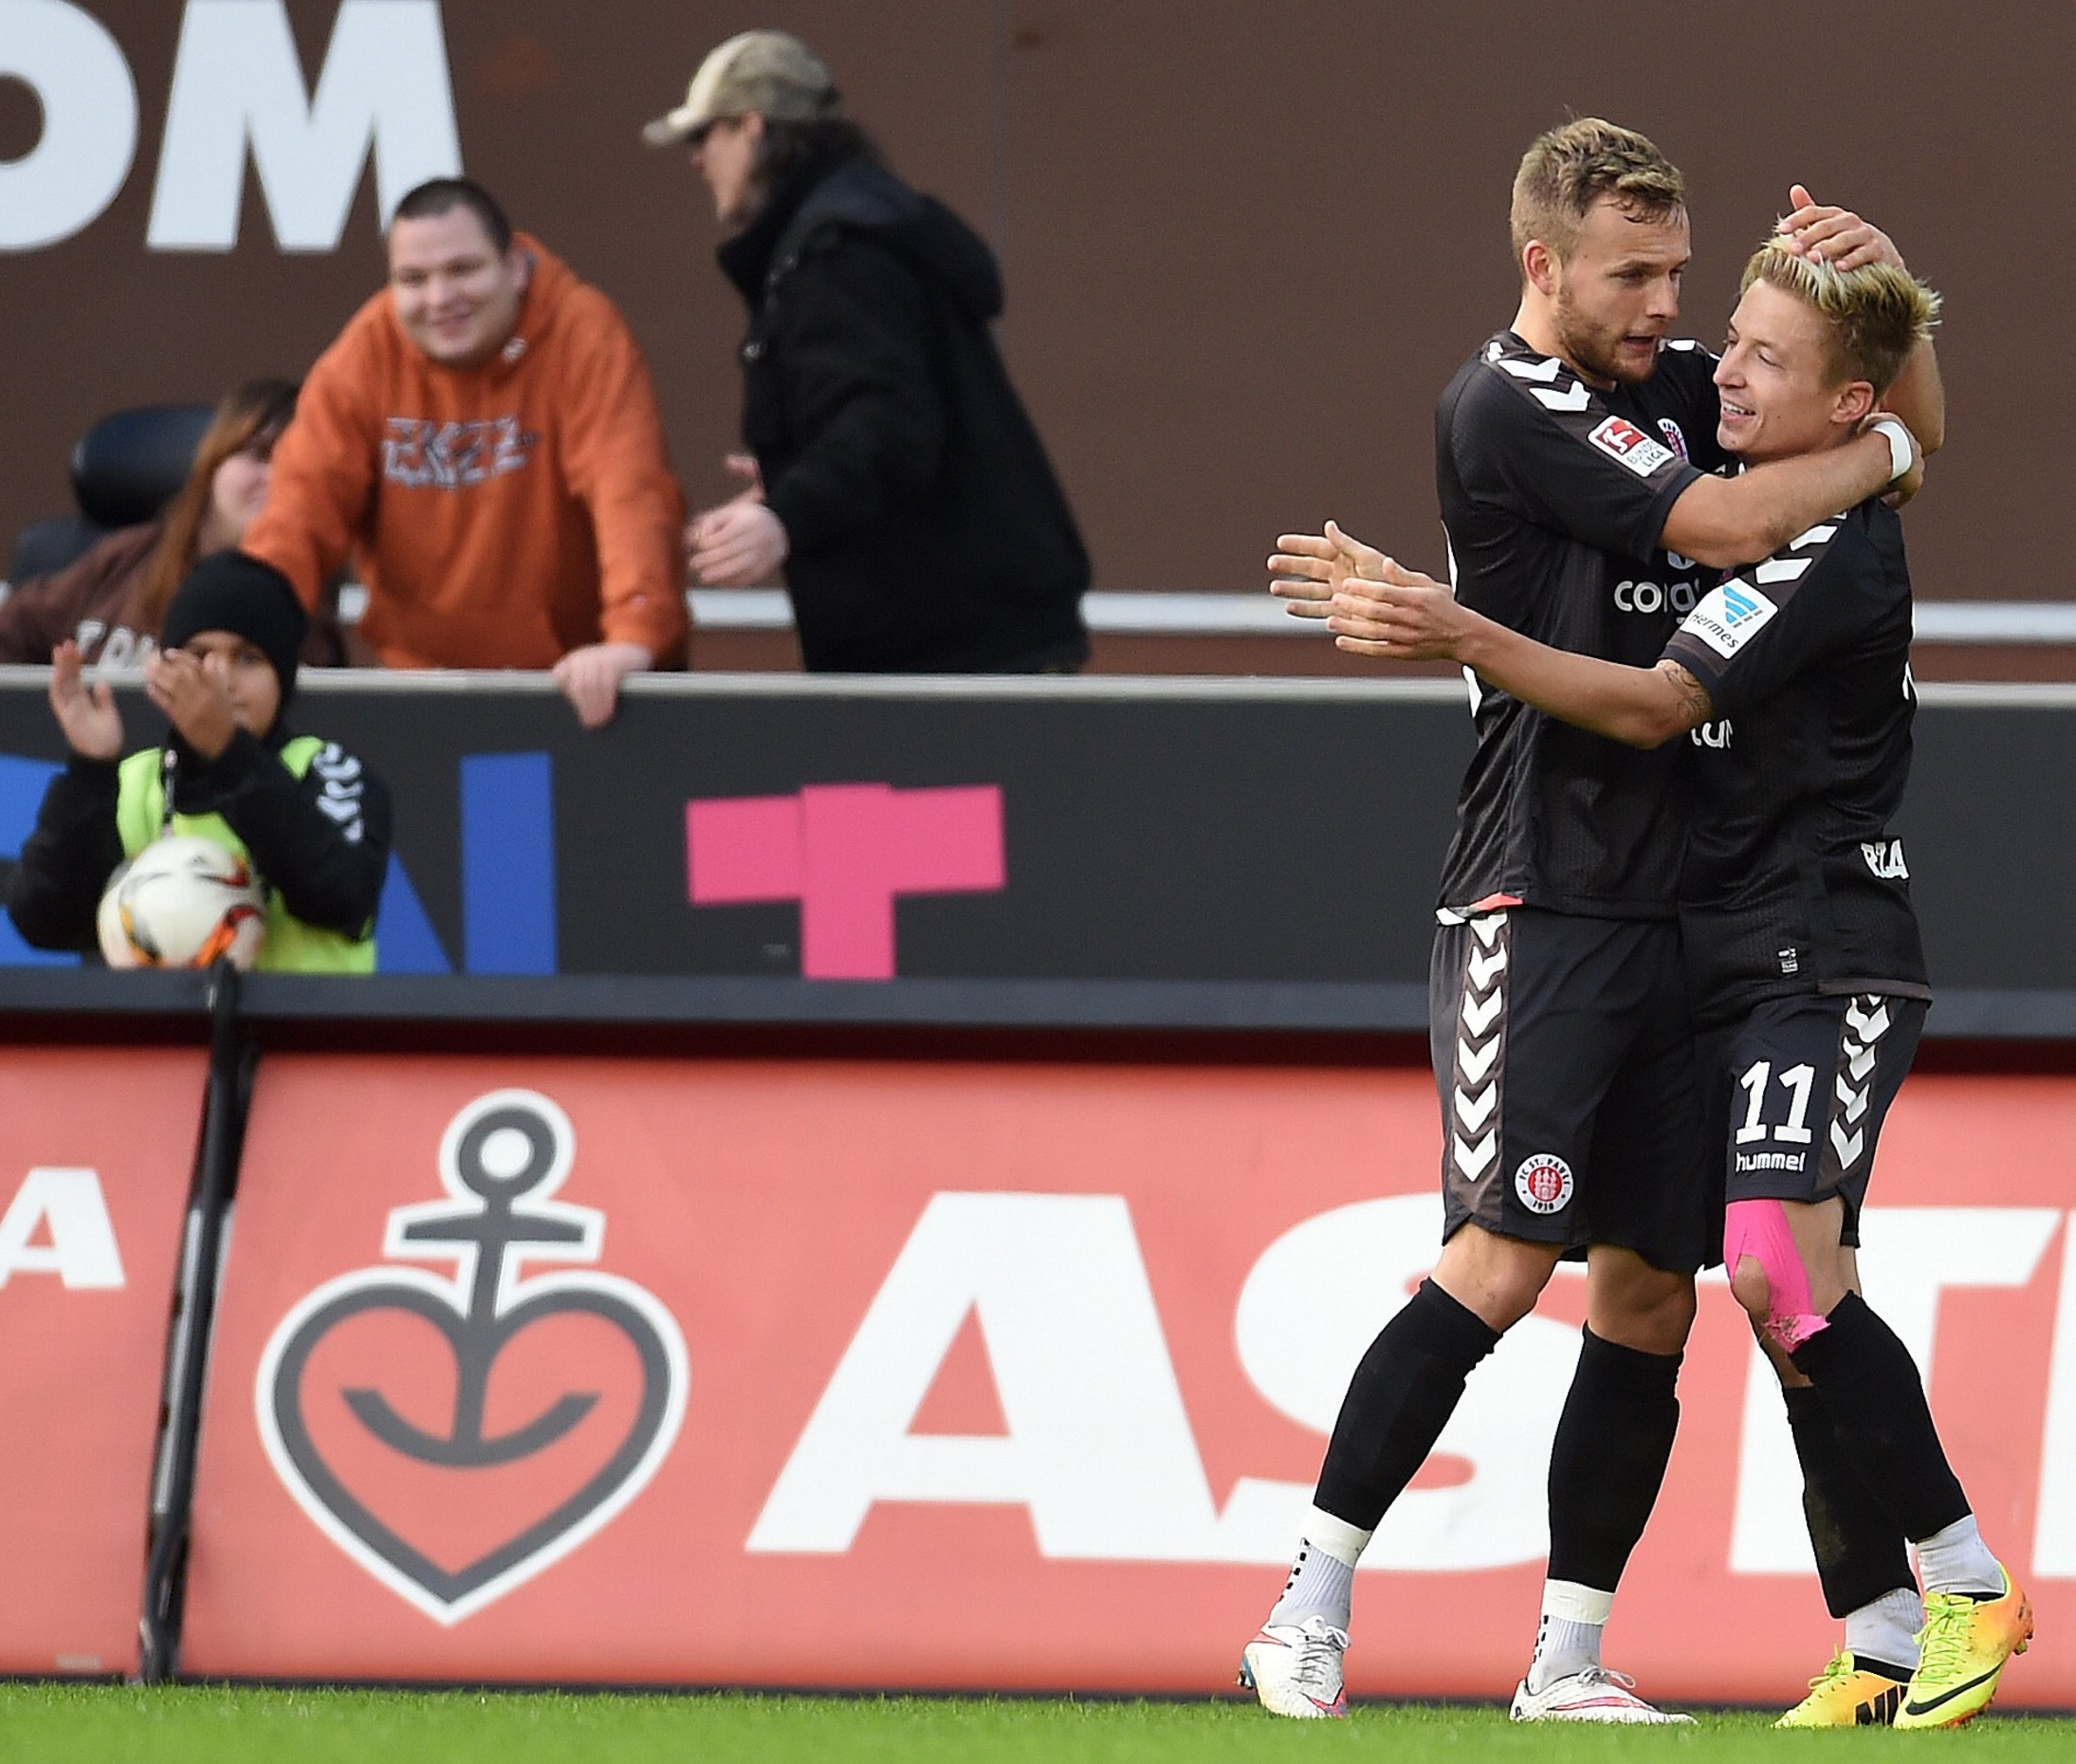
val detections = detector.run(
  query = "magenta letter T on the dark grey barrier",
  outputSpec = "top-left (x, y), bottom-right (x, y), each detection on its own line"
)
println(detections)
top-left (685, 784), bottom-right (1009, 980)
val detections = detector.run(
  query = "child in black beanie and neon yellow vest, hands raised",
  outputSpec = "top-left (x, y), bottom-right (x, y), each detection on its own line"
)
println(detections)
top-left (7, 552), bottom-right (391, 973)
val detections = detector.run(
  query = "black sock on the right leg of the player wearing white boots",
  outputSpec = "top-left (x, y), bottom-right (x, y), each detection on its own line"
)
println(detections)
top-left (1549, 1328), bottom-right (1680, 1591)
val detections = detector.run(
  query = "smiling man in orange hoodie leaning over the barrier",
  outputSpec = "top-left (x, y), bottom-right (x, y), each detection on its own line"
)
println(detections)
top-left (243, 178), bottom-right (685, 728)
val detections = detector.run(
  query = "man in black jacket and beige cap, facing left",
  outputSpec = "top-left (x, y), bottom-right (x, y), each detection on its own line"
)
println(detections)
top-left (646, 31), bottom-right (1088, 672)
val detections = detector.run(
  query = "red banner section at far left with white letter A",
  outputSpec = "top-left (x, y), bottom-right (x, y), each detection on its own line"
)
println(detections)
top-left (0, 1048), bottom-right (208, 1675)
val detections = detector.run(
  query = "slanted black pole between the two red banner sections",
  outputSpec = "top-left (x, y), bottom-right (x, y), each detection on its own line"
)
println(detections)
top-left (139, 961), bottom-right (245, 1685)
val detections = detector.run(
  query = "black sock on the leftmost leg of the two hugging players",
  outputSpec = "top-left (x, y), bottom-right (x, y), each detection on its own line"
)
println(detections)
top-left (1312, 1280), bottom-right (1498, 1532)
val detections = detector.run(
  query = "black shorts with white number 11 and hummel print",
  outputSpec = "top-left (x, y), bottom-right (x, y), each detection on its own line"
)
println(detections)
top-left (1700, 992), bottom-right (1929, 1243)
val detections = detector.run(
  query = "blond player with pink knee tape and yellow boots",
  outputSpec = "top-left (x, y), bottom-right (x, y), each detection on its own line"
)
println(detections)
top-left (1295, 239), bottom-right (2032, 1727)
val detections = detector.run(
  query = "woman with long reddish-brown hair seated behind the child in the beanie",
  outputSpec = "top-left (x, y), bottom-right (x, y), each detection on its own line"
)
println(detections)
top-left (0, 379), bottom-right (344, 669)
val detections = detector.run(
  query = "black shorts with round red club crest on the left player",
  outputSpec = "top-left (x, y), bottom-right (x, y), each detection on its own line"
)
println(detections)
top-left (1428, 907), bottom-right (1723, 1272)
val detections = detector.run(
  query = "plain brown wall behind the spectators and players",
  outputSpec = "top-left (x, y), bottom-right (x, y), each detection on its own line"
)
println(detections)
top-left (0, 0), bottom-right (2076, 597)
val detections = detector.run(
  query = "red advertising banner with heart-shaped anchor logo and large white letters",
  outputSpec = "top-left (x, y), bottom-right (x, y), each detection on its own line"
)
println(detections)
top-left (183, 1057), bottom-right (2076, 1706)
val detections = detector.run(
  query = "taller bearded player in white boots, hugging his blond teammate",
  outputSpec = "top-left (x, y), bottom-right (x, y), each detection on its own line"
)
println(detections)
top-left (1243, 117), bottom-right (1943, 1722)
